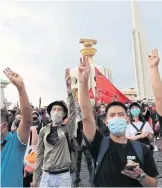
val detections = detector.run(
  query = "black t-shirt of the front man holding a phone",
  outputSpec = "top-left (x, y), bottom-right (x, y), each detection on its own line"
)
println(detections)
top-left (90, 131), bottom-right (158, 187)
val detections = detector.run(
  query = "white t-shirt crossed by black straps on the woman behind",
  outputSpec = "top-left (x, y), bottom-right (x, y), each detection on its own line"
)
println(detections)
top-left (125, 121), bottom-right (154, 137)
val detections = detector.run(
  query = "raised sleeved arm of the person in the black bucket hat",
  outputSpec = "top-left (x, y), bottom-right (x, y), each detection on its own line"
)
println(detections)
top-left (65, 69), bottom-right (76, 135)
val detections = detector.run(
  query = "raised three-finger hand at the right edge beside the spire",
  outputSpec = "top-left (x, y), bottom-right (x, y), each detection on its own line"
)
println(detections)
top-left (148, 49), bottom-right (160, 67)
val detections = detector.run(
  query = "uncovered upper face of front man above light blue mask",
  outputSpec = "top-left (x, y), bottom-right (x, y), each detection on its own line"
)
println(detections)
top-left (106, 106), bottom-right (128, 123)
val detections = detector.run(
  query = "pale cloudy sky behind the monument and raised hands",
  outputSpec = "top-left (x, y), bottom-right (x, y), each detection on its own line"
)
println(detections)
top-left (0, 1), bottom-right (162, 106)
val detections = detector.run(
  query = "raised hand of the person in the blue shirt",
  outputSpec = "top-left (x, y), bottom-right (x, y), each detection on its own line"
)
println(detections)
top-left (3, 67), bottom-right (24, 90)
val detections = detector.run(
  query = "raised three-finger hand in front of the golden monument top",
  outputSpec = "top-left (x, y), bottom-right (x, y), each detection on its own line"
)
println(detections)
top-left (78, 57), bottom-right (91, 83)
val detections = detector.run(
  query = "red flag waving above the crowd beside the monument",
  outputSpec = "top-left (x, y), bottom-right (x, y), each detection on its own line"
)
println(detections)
top-left (95, 67), bottom-right (130, 103)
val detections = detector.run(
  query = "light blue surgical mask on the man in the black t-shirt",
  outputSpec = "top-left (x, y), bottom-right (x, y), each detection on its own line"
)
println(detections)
top-left (108, 117), bottom-right (127, 136)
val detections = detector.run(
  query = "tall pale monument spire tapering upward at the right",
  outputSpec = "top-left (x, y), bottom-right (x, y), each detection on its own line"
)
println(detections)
top-left (131, 0), bottom-right (153, 99)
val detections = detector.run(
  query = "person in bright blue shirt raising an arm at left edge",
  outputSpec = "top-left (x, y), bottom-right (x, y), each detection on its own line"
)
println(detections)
top-left (1, 68), bottom-right (32, 187)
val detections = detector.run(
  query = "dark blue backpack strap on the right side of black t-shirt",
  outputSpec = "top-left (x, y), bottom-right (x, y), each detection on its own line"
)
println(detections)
top-left (130, 140), bottom-right (144, 168)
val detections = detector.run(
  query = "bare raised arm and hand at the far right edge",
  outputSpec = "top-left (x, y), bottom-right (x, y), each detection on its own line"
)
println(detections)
top-left (148, 49), bottom-right (162, 116)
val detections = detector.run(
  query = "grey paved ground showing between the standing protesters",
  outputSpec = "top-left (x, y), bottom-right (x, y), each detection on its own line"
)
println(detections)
top-left (73, 138), bottom-right (162, 187)
